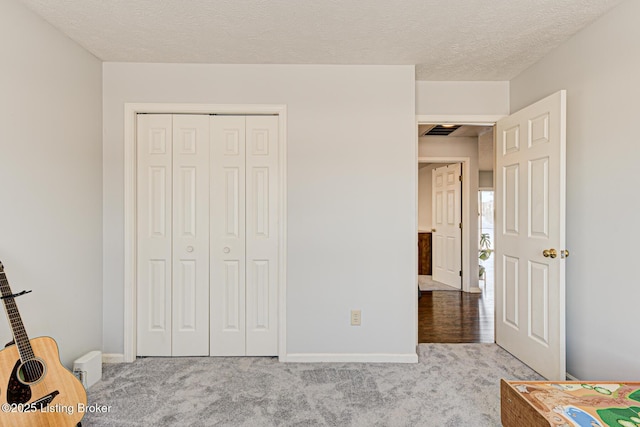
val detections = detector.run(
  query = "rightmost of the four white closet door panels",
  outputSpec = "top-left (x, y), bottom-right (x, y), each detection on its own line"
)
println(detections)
top-left (246, 116), bottom-right (279, 356)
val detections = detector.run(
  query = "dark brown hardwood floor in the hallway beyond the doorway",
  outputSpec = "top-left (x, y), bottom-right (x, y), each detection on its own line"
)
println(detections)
top-left (418, 284), bottom-right (494, 343)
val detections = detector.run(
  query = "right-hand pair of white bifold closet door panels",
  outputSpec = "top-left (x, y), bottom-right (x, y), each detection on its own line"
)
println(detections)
top-left (210, 116), bottom-right (279, 356)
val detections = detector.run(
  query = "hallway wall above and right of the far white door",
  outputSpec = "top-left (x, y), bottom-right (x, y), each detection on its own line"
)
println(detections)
top-left (418, 136), bottom-right (478, 287)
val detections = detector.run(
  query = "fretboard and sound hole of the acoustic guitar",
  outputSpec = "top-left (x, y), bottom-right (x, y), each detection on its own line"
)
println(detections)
top-left (0, 270), bottom-right (44, 383)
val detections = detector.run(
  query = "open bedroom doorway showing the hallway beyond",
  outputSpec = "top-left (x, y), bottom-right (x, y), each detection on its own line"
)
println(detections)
top-left (418, 123), bottom-right (494, 343)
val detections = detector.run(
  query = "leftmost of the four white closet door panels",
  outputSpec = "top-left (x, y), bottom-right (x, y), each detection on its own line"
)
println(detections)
top-left (136, 114), bottom-right (173, 356)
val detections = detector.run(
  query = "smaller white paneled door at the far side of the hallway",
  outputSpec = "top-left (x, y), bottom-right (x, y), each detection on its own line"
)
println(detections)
top-left (431, 163), bottom-right (462, 289)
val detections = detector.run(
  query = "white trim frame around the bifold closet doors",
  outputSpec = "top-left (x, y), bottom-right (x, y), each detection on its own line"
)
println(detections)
top-left (123, 103), bottom-right (287, 363)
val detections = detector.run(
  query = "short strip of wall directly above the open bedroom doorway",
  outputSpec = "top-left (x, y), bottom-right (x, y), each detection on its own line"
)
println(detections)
top-left (416, 81), bottom-right (509, 115)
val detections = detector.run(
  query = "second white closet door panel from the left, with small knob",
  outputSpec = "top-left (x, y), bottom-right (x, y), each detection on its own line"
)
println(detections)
top-left (172, 115), bottom-right (209, 356)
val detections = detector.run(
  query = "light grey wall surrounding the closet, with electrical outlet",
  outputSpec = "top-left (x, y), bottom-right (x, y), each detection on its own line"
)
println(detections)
top-left (103, 63), bottom-right (417, 355)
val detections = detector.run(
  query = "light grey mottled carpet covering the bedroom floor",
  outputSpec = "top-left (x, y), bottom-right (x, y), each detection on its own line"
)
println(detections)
top-left (82, 344), bottom-right (541, 427)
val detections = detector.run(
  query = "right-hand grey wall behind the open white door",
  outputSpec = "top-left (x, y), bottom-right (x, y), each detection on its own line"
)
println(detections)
top-left (511, 0), bottom-right (640, 381)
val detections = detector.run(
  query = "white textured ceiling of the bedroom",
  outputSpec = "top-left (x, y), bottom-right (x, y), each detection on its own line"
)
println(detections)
top-left (22, 0), bottom-right (621, 80)
